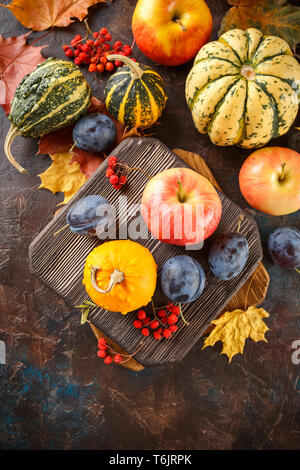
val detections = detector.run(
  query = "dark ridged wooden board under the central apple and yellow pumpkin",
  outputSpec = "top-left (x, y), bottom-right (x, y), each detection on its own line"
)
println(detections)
top-left (29, 138), bottom-right (267, 366)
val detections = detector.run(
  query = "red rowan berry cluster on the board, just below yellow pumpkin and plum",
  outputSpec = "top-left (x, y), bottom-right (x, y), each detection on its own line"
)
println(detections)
top-left (133, 303), bottom-right (181, 341)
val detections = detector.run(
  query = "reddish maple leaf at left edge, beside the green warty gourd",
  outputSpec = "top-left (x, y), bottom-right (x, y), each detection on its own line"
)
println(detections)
top-left (0, 33), bottom-right (46, 114)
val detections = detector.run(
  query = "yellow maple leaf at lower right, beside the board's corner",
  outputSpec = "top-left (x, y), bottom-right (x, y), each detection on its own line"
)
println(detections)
top-left (202, 305), bottom-right (269, 362)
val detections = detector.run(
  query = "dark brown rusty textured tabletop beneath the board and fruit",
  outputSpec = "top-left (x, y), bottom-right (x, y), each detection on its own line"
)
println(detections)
top-left (0, 0), bottom-right (300, 449)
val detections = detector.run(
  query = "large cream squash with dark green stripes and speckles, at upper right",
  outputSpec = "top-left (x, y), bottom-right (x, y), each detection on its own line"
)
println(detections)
top-left (186, 28), bottom-right (300, 148)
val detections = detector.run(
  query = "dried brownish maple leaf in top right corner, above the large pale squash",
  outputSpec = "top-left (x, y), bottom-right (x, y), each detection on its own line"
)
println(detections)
top-left (219, 0), bottom-right (300, 48)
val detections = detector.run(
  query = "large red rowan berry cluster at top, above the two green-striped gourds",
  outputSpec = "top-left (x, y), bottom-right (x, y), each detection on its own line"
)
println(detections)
top-left (62, 24), bottom-right (135, 73)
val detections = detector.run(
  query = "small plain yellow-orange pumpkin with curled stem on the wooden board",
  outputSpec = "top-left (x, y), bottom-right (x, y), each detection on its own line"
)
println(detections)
top-left (83, 240), bottom-right (157, 315)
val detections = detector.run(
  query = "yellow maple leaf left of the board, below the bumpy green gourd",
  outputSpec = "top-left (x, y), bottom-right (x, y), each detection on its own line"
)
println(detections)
top-left (38, 152), bottom-right (87, 204)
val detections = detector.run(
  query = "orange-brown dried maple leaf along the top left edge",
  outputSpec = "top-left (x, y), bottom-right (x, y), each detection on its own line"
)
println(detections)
top-left (0, 0), bottom-right (105, 31)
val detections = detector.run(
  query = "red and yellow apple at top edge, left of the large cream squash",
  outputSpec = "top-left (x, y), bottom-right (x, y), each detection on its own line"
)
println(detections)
top-left (132, 0), bottom-right (212, 65)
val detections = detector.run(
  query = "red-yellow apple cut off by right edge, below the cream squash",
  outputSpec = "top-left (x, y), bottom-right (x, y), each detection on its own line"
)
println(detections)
top-left (239, 147), bottom-right (300, 215)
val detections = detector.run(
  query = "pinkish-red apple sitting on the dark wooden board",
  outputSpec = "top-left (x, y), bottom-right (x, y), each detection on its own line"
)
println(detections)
top-left (141, 168), bottom-right (222, 246)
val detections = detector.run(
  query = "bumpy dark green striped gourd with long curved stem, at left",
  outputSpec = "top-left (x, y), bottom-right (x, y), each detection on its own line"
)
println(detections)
top-left (4, 57), bottom-right (92, 173)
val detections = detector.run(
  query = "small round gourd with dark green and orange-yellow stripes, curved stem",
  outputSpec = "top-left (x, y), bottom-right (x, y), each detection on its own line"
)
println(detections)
top-left (104, 54), bottom-right (167, 129)
